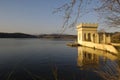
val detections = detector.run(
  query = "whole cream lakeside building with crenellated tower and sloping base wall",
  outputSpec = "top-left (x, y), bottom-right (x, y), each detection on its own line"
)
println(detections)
top-left (77, 23), bottom-right (118, 53)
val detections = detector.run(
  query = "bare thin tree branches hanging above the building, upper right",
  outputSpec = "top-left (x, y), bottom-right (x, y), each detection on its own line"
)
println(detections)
top-left (54, 0), bottom-right (120, 28)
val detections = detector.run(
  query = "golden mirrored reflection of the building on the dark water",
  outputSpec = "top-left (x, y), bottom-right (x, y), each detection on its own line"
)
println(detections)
top-left (78, 47), bottom-right (117, 67)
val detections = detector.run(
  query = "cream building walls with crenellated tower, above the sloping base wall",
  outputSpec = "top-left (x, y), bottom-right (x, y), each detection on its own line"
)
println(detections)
top-left (77, 23), bottom-right (111, 44)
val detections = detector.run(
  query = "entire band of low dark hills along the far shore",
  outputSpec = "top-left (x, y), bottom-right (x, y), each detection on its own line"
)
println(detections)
top-left (0, 32), bottom-right (77, 40)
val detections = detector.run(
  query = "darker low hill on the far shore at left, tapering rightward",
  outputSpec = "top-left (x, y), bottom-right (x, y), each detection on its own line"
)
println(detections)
top-left (0, 33), bottom-right (37, 38)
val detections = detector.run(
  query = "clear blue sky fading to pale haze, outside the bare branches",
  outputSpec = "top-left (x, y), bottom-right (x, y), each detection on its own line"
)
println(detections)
top-left (0, 0), bottom-right (119, 34)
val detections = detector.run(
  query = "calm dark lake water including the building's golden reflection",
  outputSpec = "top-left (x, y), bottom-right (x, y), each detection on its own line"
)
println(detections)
top-left (0, 39), bottom-right (118, 80)
